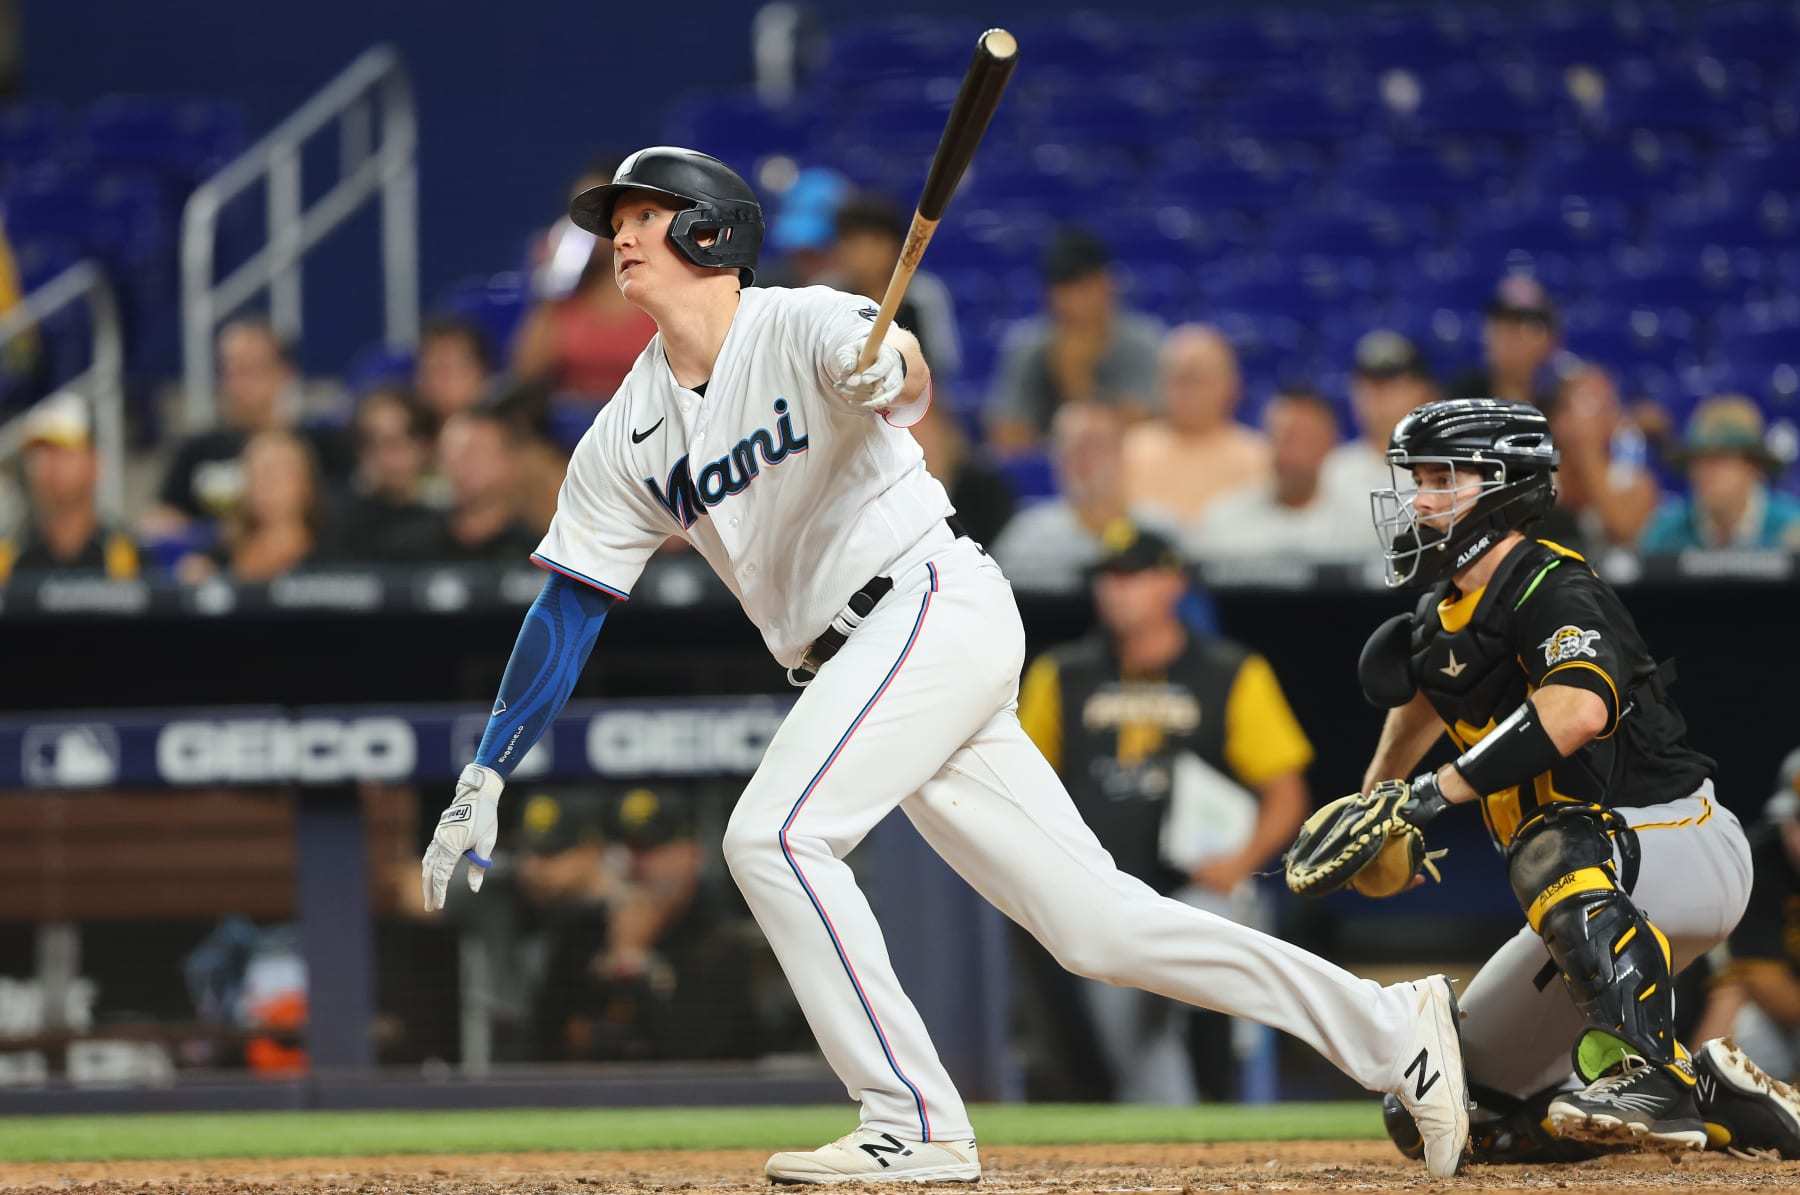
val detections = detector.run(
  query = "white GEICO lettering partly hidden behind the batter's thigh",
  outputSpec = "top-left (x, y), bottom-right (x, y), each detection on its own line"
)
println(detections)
top-left (587, 705), bottom-right (781, 776)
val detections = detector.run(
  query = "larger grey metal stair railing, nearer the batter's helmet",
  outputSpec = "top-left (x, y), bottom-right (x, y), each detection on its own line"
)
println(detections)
top-left (182, 45), bottom-right (419, 430)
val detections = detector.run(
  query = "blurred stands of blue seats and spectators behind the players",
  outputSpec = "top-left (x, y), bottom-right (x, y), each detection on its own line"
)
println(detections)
top-left (0, 4), bottom-right (1800, 589)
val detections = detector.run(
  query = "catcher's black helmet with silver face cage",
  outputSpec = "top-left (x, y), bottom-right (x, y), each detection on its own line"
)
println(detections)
top-left (1370, 398), bottom-right (1557, 587)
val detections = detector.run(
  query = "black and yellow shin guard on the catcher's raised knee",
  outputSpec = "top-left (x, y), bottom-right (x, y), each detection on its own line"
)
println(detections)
top-left (1507, 817), bottom-right (1692, 1082)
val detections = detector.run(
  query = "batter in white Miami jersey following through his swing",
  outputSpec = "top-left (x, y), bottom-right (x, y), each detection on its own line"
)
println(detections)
top-left (423, 148), bottom-right (1469, 1182)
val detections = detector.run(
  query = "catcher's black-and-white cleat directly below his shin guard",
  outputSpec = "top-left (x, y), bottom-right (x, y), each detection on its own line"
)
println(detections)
top-left (1550, 1055), bottom-right (1706, 1154)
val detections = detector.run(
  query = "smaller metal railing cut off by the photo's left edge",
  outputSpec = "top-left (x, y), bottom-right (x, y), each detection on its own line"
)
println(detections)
top-left (0, 261), bottom-right (124, 520)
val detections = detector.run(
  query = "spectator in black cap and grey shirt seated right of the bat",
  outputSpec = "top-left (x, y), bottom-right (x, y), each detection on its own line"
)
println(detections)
top-left (990, 229), bottom-right (1163, 452)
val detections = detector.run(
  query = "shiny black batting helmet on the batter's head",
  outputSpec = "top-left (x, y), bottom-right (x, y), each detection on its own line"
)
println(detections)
top-left (569, 146), bottom-right (763, 286)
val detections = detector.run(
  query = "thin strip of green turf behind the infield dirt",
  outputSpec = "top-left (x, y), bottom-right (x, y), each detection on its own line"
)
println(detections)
top-left (0, 1100), bottom-right (1382, 1163)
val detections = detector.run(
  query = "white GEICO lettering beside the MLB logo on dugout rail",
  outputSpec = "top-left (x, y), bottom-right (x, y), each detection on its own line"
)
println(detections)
top-left (157, 718), bottom-right (418, 785)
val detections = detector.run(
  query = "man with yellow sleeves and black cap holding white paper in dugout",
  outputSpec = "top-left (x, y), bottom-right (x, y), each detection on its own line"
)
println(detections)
top-left (1019, 520), bottom-right (1312, 1103)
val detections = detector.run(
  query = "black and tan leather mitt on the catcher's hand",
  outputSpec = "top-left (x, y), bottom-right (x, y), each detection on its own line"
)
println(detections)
top-left (1282, 779), bottom-right (1444, 898)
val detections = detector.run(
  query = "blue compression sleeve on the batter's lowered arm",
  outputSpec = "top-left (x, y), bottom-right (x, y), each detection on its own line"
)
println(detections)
top-left (475, 572), bottom-right (612, 776)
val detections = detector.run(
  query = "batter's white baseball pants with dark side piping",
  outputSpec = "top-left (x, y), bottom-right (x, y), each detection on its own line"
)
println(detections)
top-left (724, 529), bottom-right (1415, 1141)
